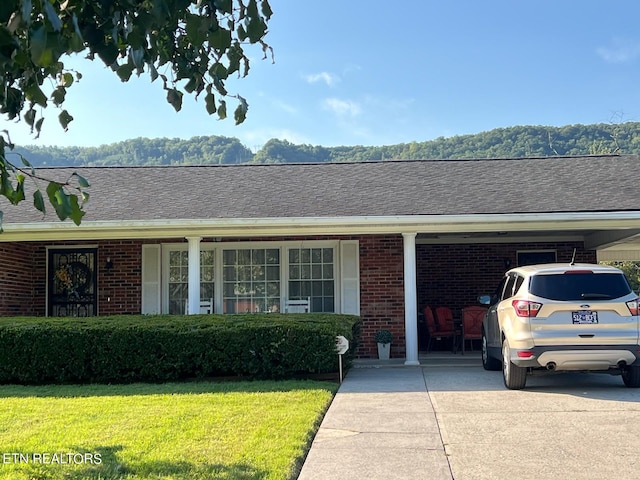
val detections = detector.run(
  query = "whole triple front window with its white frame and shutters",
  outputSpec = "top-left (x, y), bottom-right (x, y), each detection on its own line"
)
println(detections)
top-left (151, 240), bottom-right (360, 315)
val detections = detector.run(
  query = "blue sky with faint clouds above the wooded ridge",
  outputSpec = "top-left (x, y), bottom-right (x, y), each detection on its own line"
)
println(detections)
top-left (2, 0), bottom-right (640, 151)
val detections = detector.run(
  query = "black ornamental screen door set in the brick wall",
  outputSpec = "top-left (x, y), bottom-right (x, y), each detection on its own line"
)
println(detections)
top-left (47, 248), bottom-right (98, 317)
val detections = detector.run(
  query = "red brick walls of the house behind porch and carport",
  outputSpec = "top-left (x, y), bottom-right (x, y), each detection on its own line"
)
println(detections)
top-left (0, 235), bottom-right (596, 358)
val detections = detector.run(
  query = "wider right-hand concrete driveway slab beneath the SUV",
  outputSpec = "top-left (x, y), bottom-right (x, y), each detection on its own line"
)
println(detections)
top-left (423, 366), bottom-right (640, 480)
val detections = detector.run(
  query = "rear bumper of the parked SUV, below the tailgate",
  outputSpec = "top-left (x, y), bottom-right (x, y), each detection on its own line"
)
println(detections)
top-left (511, 345), bottom-right (640, 371)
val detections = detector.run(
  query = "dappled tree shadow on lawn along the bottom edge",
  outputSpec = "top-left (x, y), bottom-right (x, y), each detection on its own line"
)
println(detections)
top-left (9, 445), bottom-right (268, 480)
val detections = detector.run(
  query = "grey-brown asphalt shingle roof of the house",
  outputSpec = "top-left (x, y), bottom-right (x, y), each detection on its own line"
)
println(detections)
top-left (0, 155), bottom-right (640, 223)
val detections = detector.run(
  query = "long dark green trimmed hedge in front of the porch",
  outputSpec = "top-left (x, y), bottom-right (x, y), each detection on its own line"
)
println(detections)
top-left (0, 313), bottom-right (360, 384)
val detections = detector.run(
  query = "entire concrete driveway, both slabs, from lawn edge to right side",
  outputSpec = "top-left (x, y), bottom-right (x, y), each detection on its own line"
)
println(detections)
top-left (298, 355), bottom-right (640, 480)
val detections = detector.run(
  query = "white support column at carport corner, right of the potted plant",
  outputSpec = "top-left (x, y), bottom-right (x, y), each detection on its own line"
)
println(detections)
top-left (402, 233), bottom-right (420, 365)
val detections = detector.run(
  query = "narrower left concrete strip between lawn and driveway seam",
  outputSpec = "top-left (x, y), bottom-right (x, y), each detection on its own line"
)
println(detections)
top-left (298, 357), bottom-right (460, 480)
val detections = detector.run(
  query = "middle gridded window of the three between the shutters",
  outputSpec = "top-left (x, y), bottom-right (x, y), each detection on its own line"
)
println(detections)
top-left (222, 248), bottom-right (280, 313)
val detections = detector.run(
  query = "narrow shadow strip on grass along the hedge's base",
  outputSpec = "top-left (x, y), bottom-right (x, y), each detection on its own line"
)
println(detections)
top-left (0, 380), bottom-right (339, 398)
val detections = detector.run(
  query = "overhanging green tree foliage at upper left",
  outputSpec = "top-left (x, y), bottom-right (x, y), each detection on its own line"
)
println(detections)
top-left (0, 0), bottom-right (272, 227)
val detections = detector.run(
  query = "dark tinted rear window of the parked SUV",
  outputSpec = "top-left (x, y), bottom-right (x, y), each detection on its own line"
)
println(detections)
top-left (529, 273), bottom-right (632, 301)
